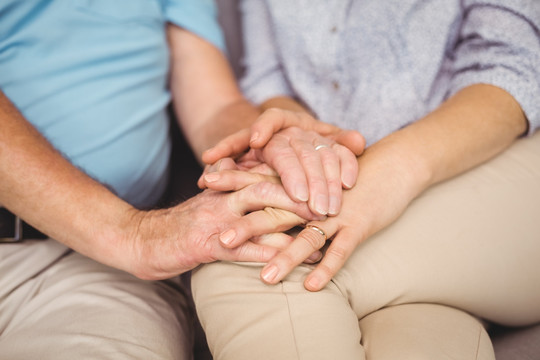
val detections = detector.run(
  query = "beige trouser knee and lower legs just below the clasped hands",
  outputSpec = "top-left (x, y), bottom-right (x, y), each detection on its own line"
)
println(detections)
top-left (192, 262), bottom-right (494, 360)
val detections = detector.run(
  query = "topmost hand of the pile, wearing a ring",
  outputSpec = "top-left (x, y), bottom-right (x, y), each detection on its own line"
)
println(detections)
top-left (199, 109), bottom-right (365, 215)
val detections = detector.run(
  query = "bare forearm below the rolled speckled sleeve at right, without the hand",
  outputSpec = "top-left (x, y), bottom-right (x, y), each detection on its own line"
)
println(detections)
top-left (376, 85), bottom-right (527, 195)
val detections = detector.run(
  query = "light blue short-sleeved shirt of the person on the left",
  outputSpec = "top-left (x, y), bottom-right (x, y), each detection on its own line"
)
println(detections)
top-left (0, 0), bottom-right (224, 206)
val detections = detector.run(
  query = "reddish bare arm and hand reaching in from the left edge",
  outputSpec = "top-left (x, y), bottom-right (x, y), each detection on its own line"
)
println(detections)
top-left (0, 92), bottom-right (314, 279)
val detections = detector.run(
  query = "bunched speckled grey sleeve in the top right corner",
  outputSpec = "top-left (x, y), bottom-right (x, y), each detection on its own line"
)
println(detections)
top-left (450, 0), bottom-right (540, 133)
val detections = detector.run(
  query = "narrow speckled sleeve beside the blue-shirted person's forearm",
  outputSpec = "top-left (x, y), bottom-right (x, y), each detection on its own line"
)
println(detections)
top-left (240, 0), bottom-right (293, 104)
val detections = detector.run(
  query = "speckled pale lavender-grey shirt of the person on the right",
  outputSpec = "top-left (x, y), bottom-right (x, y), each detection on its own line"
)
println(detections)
top-left (242, 0), bottom-right (540, 144)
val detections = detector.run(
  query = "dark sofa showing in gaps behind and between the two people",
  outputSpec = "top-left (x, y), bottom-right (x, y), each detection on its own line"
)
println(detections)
top-left (172, 0), bottom-right (540, 360)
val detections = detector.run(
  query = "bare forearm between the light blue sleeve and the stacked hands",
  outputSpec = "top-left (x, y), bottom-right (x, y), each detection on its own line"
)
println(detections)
top-left (168, 25), bottom-right (260, 160)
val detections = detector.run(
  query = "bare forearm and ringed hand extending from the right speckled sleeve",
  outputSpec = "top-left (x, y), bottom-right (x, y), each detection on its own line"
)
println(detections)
top-left (201, 84), bottom-right (527, 291)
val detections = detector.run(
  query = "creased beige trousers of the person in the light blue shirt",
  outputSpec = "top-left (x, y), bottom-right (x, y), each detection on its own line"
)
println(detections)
top-left (0, 240), bottom-right (193, 360)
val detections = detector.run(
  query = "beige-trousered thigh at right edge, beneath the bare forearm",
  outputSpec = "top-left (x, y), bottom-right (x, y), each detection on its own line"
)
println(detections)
top-left (334, 133), bottom-right (540, 325)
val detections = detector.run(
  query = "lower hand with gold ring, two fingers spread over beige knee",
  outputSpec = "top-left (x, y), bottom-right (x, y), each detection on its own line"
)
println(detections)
top-left (207, 146), bottom-right (423, 291)
